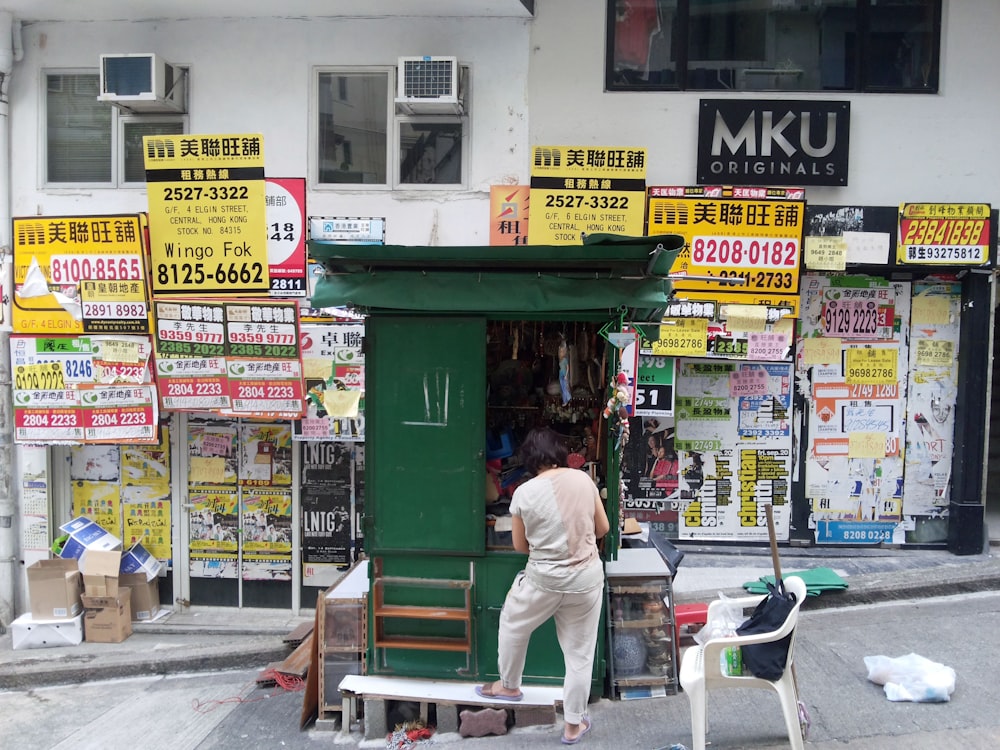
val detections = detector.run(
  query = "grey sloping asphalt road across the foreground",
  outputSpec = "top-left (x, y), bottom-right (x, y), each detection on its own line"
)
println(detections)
top-left (0, 592), bottom-right (1000, 750)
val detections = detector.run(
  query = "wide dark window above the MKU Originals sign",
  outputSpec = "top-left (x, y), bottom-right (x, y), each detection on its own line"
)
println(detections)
top-left (605, 0), bottom-right (941, 94)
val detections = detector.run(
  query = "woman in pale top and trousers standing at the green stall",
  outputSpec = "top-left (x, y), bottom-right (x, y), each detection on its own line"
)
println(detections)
top-left (476, 428), bottom-right (611, 745)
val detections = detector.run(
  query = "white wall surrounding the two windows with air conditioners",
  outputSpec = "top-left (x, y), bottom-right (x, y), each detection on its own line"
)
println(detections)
top-left (10, 17), bottom-right (530, 245)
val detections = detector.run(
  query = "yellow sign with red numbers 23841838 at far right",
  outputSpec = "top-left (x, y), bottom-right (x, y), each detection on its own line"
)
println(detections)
top-left (896, 203), bottom-right (990, 266)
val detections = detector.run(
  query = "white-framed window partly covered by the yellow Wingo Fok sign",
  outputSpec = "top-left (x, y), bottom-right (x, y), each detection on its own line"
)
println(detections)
top-left (44, 72), bottom-right (187, 188)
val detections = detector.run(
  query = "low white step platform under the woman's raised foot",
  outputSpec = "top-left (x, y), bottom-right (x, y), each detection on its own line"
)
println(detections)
top-left (339, 674), bottom-right (562, 708)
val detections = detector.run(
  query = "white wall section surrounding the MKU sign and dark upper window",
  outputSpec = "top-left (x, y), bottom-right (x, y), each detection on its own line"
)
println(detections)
top-left (528, 0), bottom-right (1000, 206)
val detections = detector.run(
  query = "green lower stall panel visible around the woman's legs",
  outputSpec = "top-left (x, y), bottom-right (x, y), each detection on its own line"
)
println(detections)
top-left (476, 552), bottom-right (606, 697)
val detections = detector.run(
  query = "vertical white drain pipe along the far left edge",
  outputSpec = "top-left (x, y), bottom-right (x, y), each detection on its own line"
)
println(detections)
top-left (0, 10), bottom-right (24, 633)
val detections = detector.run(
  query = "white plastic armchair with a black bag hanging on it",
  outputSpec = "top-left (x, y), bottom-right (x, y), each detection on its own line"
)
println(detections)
top-left (680, 576), bottom-right (806, 750)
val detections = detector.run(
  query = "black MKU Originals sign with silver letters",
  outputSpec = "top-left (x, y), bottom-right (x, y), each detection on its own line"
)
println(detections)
top-left (698, 99), bottom-right (851, 187)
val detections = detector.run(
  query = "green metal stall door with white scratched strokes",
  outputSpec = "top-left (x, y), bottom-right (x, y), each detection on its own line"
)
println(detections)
top-left (366, 316), bottom-right (486, 555)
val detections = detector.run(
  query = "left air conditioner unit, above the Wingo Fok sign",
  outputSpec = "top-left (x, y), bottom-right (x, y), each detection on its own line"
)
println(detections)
top-left (97, 53), bottom-right (187, 114)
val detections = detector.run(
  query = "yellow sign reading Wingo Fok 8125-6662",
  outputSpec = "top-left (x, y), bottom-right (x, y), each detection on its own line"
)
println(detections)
top-left (142, 135), bottom-right (270, 295)
